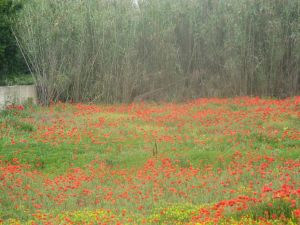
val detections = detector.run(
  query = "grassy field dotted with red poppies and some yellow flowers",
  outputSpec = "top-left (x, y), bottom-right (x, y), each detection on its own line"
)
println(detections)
top-left (0, 97), bottom-right (300, 225)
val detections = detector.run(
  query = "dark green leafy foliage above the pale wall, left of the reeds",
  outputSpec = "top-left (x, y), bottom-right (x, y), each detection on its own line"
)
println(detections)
top-left (0, 0), bottom-right (27, 80)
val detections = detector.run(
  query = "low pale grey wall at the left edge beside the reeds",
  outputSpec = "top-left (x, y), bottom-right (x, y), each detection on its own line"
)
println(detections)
top-left (0, 85), bottom-right (37, 109)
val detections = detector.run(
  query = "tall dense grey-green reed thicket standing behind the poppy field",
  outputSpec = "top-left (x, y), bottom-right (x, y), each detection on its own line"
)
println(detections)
top-left (16, 0), bottom-right (300, 103)
